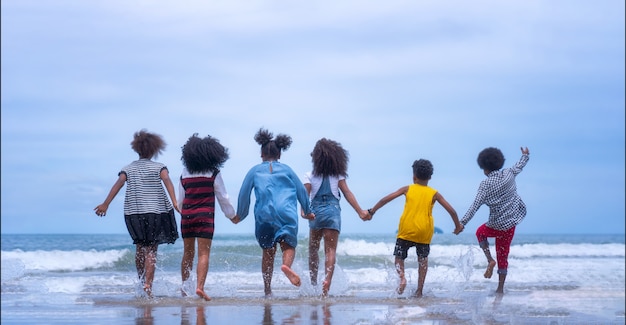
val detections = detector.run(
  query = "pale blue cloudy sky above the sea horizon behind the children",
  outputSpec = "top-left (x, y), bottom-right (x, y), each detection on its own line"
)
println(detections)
top-left (0, 0), bottom-right (625, 234)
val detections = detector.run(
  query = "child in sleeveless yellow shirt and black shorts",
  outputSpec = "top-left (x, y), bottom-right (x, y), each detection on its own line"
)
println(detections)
top-left (368, 159), bottom-right (463, 297)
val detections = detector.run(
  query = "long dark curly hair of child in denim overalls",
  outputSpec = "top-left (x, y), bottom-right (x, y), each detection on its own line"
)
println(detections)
top-left (311, 138), bottom-right (349, 177)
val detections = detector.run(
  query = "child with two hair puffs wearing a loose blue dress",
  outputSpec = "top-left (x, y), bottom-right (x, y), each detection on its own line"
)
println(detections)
top-left (234, 129), bottom-right (315, 297)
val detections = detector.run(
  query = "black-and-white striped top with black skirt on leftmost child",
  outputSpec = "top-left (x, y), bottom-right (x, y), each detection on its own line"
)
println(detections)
top-left (118, 159), bottom-right (178, 245)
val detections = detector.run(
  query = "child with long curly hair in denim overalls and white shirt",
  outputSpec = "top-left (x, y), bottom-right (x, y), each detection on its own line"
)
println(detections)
top-left (303, 138), bottom-right (369, 296)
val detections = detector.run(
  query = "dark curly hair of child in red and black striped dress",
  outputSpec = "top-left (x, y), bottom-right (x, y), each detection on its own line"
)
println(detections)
top-left (180, 133), bottom-right (229, 174)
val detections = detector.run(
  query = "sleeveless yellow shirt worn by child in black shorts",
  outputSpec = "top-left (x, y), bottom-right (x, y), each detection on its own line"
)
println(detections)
top-left (398, 184), bottom-right (437, 244)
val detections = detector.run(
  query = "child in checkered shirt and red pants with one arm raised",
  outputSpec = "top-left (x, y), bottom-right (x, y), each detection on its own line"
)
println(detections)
top-left (461, 147), bottom-right (530, 294)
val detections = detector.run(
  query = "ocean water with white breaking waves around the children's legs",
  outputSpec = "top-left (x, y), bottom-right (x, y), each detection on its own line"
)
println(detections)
top-left (1, 233), bottom-right (626, 325)
